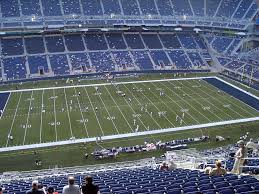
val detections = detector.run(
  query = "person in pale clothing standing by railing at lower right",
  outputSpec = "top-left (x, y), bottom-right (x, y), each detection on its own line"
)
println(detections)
top-left (232, 140), bottom-right (247, 174)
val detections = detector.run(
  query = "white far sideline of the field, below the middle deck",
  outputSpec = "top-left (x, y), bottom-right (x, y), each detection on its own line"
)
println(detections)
top-left (0, 76), bottom-right (217, 93)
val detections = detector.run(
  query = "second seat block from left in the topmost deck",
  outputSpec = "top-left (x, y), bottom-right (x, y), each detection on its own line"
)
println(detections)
top-left (20, 0), bottom-right (41, 16)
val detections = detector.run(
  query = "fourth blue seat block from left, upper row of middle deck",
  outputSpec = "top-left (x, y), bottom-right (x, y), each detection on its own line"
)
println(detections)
top-left (64, 34), bottom-right (85, 51)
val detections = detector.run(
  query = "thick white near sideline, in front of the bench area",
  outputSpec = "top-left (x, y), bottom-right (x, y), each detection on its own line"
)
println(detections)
top-left (0, 117), bottom-right (259, 152)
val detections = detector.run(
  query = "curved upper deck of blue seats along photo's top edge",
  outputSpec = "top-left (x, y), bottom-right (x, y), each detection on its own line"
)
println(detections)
top-left (0, 0), bottom-right (257, 29)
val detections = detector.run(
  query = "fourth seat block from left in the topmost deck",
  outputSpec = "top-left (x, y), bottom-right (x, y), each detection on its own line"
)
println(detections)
top-left (62, 0), bottom-right (81, 15)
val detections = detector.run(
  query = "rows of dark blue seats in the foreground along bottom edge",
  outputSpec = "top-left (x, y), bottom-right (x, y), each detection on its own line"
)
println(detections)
top-left (3, 167), bottom-right (259, 194)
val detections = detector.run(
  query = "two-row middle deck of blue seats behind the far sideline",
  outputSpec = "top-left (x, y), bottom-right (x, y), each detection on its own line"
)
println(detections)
top-left (1, 33), bottom-right (211, 80)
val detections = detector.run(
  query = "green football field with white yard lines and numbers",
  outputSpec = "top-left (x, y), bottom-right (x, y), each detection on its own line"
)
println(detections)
top-left (0, 78), bottom-right (259, 147)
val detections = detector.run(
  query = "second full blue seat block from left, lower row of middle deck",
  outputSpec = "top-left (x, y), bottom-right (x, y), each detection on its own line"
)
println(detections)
top-left (28, 55), bottom-right (49, 74)
